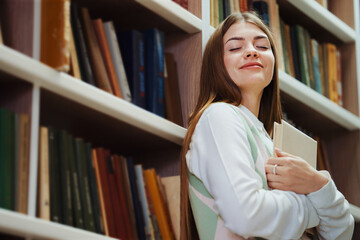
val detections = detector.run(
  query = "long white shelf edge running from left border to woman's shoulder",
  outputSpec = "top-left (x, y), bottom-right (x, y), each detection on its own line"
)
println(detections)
top-left (0, 45), bottom-right (186, 145)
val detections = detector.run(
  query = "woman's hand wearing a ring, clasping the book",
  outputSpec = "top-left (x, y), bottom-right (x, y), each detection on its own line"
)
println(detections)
top-left (265, 149), bottom-right (329, 194)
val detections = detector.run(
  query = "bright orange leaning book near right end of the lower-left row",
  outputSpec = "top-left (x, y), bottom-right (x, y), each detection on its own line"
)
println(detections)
top-left (144, 168), bottom-right (174, 239)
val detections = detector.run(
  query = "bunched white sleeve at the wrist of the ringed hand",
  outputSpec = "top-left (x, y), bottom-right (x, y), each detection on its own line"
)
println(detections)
top-left (307, 171), bottom-right (354, 240)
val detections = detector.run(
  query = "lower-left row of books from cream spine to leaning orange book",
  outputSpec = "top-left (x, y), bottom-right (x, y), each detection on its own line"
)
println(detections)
top-left (38, 126), bottom-right (174, 239)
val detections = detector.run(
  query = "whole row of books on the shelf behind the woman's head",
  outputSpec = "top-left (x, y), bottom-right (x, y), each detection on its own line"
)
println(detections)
top-left (211, 0), bottom-right (343, 106)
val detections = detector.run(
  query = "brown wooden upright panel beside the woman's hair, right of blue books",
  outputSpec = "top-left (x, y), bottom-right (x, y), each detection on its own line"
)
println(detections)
top-left (165, 33), bottom-right (202, 127)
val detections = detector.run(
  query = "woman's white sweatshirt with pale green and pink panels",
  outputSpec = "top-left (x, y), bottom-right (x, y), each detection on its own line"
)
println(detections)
top-left (186, 103), bottom-right (354, 240)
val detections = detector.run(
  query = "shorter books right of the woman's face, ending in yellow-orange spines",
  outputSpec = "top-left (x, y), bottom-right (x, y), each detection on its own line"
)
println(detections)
top-left (280, 19), bottom-right (343, 106)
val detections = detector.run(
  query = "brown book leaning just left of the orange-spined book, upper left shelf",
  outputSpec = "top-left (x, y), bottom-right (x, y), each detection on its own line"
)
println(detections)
top-left (81, 8), bottom-right (113, 94)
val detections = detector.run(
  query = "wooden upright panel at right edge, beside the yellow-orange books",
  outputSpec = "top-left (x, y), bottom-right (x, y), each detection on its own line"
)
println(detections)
top-left (339, 43), bottom-right (359, 116)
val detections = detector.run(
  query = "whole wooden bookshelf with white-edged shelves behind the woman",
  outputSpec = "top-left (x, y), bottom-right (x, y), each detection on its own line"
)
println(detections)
top-left (0, 0), bottom-right (360, 239)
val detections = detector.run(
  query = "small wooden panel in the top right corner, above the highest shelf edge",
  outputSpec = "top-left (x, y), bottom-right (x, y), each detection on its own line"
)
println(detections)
top-left (328, 0), bottom-right (357, 28)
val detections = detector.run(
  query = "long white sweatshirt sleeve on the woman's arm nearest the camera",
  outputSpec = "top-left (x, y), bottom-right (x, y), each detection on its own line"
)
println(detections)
top-left (187, 104), bottom-right (319, 239)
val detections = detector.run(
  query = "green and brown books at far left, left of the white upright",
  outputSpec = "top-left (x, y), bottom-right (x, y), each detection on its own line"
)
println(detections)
top-left (0, 108), bottom-right (30, 214)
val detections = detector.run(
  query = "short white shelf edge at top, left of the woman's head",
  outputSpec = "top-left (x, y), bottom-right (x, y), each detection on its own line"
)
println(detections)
top-left (135, 0), bottom-right (202, 33)
